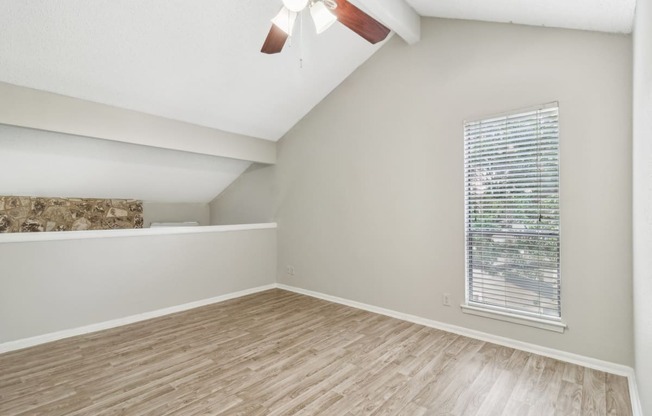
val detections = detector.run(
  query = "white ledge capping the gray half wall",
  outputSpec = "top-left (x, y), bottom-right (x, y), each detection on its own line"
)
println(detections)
top-left (0, 222), bottom-right (278, 244)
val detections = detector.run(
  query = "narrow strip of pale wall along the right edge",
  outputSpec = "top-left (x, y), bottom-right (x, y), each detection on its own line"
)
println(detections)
top-left (633, 0), bottom-right (652, 408)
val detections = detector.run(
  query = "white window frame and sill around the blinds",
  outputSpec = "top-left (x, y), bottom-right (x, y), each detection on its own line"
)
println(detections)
top-left (460, 101), bottom-right (567, 332)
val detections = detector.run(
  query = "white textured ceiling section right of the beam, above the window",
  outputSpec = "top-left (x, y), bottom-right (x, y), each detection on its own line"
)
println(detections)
top-left (406, 0), bottom-right (636, 33)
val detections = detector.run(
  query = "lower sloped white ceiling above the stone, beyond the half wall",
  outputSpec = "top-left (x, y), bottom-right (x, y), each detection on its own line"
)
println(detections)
top-left (0, 125), bottom-right (250, 203)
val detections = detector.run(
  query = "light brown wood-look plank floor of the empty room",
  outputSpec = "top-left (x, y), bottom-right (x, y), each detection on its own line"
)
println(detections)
top-left (0, 290), bottom-right (631, 416)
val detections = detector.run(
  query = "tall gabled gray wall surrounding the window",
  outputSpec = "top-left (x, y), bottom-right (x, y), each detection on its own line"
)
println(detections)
top-left (214, 19), bottom-right (633, 365)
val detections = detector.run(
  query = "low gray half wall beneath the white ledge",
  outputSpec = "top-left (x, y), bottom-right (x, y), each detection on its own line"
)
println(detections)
top-left (0, 229), bottom-right (276, 343)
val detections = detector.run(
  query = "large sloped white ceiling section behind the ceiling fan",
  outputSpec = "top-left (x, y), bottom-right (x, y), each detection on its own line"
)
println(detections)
top-left (0, 0), bottom-right (388, 140)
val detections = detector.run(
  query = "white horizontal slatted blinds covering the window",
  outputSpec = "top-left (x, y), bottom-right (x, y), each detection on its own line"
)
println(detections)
top-left (464, 103), bottom-right (561, 320)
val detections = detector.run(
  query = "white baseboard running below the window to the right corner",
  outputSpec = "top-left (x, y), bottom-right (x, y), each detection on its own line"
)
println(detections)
top-left (276, 283), bottom-right (643, 416)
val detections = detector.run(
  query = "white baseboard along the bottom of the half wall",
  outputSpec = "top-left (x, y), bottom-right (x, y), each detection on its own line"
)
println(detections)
top-left (0, 283), bottom-right (276, 354)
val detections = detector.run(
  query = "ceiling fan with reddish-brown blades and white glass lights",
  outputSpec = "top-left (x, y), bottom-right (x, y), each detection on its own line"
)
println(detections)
top-left (260, 0), bottom-right (390, 54)
